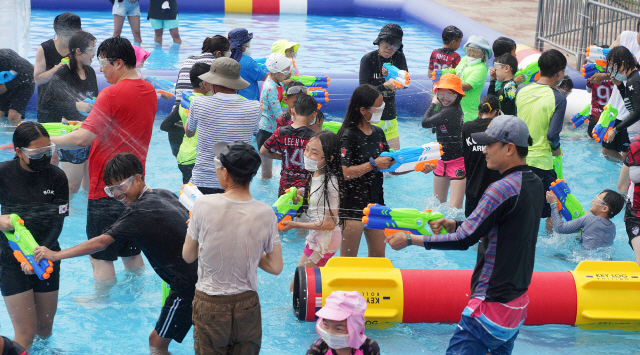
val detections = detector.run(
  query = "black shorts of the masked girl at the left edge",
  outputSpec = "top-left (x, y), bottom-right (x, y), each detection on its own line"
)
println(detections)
top-left (0, 262), bottom-right (60, 297)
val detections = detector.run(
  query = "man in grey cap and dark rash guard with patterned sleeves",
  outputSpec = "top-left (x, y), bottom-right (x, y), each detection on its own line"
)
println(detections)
top-left (386, 116), bottom-right (545, 354)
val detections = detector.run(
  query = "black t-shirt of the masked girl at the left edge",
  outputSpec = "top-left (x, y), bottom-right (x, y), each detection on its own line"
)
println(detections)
top-left (0, 159), bottom-right (69, 270)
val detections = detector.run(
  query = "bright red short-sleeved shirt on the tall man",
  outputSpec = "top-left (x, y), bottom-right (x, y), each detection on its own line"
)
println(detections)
top-left (82, 79), bottom-right (158, 200)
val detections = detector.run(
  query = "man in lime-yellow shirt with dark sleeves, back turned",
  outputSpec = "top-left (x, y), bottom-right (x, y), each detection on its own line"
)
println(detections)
top-left (516, 49), bottom-right (567, 228)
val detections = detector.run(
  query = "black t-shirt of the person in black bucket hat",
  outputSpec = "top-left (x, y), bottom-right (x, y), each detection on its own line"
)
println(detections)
top-left (359, 49), bottom-right (409, 121)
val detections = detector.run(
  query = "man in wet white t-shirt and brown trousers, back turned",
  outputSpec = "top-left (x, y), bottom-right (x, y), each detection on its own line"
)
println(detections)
top-left (182, 140), bottom-right (282, 354)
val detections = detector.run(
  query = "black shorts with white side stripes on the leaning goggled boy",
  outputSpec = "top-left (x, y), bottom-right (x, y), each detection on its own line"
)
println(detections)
top-left (155, 285), bottom-right (196, 343)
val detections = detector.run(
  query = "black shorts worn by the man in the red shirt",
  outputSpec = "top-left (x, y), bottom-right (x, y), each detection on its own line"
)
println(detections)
top-left (87, 197), bottom-right (140, 261)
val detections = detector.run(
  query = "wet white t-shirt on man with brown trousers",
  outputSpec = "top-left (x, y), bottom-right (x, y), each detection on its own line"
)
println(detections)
top-left (187, 194), bottom-right (280, 296)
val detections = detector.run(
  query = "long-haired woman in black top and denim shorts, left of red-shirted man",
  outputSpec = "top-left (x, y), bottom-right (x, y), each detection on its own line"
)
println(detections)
top-left (41, 31), bottom-right (98, 193)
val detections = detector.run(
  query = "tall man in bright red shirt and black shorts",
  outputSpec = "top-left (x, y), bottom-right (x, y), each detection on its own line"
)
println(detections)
top-left (51, 36), bottom-right (158, 279)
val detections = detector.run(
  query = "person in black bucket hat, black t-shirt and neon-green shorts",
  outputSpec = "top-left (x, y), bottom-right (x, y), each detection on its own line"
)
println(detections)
top-left (360, 23), bottom-right (409, 150)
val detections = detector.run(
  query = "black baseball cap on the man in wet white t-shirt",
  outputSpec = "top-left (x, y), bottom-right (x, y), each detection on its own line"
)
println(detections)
top-left (211, 141), bottom-right (261, 177)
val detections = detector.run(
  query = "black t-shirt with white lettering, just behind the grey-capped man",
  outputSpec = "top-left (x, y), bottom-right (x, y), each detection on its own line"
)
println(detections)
top-left (462, 118), bottom-right (501, 198)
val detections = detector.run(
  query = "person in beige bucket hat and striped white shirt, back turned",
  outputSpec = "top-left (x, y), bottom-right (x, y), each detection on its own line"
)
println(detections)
top-left (184, 57), bottom-right (262, 194)
